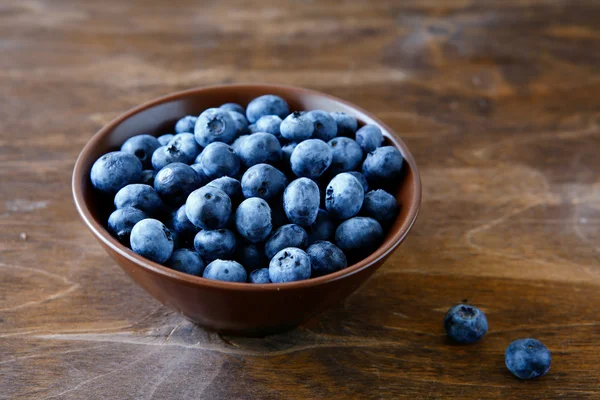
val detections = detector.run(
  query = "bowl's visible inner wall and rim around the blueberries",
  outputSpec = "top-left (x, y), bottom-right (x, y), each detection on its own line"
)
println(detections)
top-left (73, 85), bottom-right (421, 290)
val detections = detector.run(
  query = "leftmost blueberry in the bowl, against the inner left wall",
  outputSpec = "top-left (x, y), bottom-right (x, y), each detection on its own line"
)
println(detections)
top-left (90, 151), bottom-right (142, 195)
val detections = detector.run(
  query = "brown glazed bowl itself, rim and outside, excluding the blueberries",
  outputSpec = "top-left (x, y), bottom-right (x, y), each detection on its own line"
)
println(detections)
top-left (73, 85), bottom-right (421, 335)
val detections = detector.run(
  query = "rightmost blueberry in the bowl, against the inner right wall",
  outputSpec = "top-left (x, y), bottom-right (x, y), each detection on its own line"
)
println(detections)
top-left (362, 146), bottom-right (403, 186)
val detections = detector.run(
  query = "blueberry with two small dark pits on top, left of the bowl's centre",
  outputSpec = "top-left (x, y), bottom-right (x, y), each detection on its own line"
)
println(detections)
top-left (185, 186), bottom-right (231, 229)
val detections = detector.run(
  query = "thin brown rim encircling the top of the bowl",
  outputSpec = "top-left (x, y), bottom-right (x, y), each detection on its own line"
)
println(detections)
top-left (71, 83), bottom-right (422, 292)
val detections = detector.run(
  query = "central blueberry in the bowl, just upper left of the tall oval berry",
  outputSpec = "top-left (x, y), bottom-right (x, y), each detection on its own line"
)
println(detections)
top-left (242, 164), bottom-right (287, 201)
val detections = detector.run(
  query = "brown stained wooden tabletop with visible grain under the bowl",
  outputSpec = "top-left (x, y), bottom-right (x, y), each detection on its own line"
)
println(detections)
top-left (0, 0), bottom-right (600, 399)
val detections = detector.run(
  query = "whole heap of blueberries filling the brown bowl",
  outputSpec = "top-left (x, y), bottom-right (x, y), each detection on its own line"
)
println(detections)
top-left (91, 95), bottom-right (403, 283)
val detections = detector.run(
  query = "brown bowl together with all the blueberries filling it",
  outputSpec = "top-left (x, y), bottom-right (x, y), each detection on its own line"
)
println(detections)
top-left (72, 85), bottom-right (421, 335)
